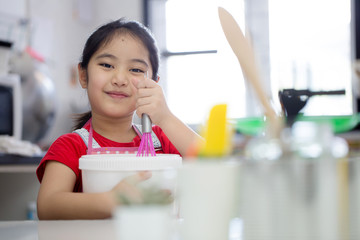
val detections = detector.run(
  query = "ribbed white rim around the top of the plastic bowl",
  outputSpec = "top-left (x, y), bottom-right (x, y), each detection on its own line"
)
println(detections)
top-left (79, 154), bottom-right (182, 171)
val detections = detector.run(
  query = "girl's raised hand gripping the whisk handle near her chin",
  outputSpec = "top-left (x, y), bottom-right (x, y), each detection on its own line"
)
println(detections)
top-left (134, 78), bottom-right (171, 127)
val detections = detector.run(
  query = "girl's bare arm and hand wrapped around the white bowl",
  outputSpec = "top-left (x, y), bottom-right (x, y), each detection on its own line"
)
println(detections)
top-left (37, 161), bottom-right (150, 220)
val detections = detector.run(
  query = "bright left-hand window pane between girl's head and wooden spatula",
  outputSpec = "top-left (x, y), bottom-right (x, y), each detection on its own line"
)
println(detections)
top-left (150, 0), bottom-right (245, 124)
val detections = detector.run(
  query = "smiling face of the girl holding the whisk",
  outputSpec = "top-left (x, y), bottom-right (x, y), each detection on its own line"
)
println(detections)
top-left (80, 33), bottom-right (152, 118)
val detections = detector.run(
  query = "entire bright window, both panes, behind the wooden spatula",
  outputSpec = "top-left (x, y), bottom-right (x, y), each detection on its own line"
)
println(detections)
top-left (148, 0), bottom-right (353, 124)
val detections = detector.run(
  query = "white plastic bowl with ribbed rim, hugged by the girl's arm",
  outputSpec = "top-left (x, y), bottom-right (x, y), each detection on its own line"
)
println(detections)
top-left (79, 154), bottom-right (182, 192)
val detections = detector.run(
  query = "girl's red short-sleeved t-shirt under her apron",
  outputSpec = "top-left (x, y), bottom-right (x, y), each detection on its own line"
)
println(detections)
top-left (36, 124), bottom-right (180, 192)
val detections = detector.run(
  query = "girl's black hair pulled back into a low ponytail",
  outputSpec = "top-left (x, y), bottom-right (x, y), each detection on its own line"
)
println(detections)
top-left (73, 18), bottom-right (160, 129)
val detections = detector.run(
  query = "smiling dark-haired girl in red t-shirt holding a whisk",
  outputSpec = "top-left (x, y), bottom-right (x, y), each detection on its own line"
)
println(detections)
top-left (36, 19), bottom-right (200, 219)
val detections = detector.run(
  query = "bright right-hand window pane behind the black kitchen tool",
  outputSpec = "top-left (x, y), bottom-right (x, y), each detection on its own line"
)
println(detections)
top-left (269, 0), bottom-right (353, 115)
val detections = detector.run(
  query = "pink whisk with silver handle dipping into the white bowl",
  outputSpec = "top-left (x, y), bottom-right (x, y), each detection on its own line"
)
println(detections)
top-left (136, 113), bottom-right (156, 157)
